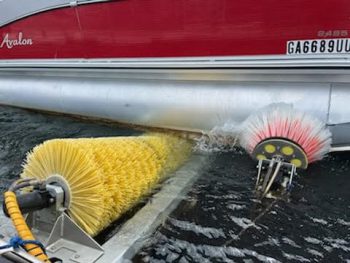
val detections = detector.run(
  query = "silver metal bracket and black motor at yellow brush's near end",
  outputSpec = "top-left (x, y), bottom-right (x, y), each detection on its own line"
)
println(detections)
top-left (8, 182), bottom-right (104, 263)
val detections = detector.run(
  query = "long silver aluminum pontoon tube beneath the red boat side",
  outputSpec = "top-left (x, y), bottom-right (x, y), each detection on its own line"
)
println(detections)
top-left (0, 69), bottom-right (350, 144)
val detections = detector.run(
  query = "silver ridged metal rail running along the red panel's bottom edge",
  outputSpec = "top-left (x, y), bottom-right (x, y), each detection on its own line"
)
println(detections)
top-left (0, 54), bottom-right (350, 69)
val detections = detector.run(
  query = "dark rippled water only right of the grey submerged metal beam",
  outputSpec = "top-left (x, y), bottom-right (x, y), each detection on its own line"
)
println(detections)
top-left (133, 152), bottom-right (350, 262)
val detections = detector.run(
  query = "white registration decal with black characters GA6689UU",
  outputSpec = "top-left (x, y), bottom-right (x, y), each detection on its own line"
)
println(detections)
top-left (287, 38), bottom-right (350, 55)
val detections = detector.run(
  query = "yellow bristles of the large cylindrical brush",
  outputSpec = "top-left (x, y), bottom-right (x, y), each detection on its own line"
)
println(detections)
top-left (22, 134), bottom-right (191, 235)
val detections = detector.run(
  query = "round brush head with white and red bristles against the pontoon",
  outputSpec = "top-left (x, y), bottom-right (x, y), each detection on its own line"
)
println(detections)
top-left (239, 103), bottom-right (331, 168)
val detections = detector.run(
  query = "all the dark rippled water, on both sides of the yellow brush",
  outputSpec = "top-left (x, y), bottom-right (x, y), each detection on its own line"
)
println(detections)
top-left (0, 106), bottom-right (350, 263)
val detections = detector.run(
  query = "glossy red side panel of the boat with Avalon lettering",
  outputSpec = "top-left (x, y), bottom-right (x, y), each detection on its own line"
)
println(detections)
top-left (0, 0), bottom-right (350, 59)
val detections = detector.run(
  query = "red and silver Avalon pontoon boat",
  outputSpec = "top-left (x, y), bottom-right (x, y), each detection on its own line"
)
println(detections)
top-left (0, 0), bottom-right (350, 145)
